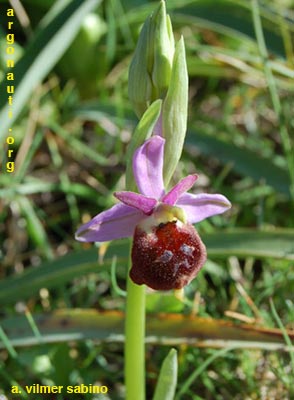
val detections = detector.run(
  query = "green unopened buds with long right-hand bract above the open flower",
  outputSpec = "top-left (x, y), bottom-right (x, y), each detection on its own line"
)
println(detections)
top-left (129, 0), bottom-right (188, 186)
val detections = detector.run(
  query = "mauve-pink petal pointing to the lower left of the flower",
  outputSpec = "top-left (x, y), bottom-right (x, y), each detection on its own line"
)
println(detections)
top-left (76, 204), bottom-right (144, 242)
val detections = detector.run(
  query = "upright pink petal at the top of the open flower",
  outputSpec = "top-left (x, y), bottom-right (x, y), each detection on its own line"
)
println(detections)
top-left (133, 136), bottom-right (165, 199)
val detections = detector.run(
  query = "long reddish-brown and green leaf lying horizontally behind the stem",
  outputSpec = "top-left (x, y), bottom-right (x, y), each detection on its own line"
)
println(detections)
top-left (0, 309), bottom-right (294, 350)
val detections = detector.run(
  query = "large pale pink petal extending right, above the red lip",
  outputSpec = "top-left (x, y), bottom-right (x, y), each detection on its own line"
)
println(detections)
top-left (177, 193), bottom-right (231, 224)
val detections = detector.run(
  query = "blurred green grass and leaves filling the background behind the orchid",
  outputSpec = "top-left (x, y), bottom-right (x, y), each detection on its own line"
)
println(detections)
top-left (0, 0), bottom-right (294, 400)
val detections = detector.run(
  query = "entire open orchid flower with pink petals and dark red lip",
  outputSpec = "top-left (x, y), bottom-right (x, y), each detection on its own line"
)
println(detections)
top-left (76, 136), bottom-right (231, 290)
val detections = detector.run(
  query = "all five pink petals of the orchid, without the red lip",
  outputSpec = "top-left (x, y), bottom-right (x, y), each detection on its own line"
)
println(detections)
top-left (76, 136), bottom-right (231, 242)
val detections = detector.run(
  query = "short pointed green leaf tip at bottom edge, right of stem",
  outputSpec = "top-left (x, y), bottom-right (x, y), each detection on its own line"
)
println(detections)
top-left (153, 349), bottom-right (178, 400)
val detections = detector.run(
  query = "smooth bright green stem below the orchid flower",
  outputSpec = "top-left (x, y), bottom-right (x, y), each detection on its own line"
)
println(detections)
top-left (125, 250), bottom-right (146, 400)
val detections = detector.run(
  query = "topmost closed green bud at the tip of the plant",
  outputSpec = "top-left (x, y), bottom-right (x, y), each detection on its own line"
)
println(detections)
top-left (129, 0), bottom-right (175, 118)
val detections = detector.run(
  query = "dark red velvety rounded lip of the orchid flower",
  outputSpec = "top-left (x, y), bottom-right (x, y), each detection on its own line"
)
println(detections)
top-left (130, 220), bottom-right (206, 290)
